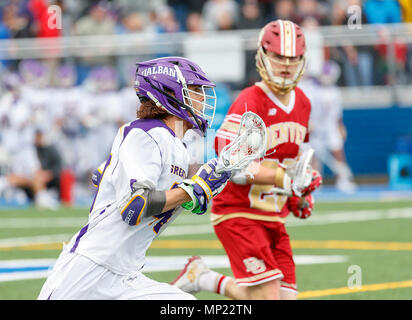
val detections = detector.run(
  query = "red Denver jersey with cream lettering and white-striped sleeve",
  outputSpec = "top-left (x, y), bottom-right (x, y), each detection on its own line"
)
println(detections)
top-left (211, 82), bottom-right (311, 224)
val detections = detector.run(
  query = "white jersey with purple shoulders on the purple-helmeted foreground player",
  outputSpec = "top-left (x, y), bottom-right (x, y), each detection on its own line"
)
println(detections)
top-left (66, 119), bottom-right (189, 275)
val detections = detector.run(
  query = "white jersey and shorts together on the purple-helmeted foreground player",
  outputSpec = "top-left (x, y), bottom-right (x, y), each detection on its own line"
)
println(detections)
top-left (39, 119), bottom-right (193, 299)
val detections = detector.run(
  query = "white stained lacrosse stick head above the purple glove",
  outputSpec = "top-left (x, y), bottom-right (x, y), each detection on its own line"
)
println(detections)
top-left (216, 111), bottom-right (267, 173)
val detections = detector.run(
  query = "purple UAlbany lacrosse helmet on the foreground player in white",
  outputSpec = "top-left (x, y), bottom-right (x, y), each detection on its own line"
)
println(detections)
top-left (135, 57), bottom-right (216, 135)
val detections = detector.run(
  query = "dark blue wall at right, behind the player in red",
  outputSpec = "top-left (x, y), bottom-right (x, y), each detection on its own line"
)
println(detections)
top-left (334, 106), bottom-right (412, 176)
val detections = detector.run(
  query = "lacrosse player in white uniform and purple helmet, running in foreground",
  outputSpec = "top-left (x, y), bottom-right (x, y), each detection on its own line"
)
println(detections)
top-left (38, 57), bottom-right (231, 300)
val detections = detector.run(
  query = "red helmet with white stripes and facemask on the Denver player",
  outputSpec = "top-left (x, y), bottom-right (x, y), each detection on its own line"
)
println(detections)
top-left (256, 20), bottom-right (306, 94)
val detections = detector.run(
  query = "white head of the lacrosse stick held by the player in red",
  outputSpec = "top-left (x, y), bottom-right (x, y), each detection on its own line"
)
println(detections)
top-left (292, 148), bottom-right (315, 197)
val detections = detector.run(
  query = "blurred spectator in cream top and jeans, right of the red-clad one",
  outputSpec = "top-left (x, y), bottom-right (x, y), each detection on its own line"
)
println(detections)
top-left (73, 1), bottom-right (116, 83)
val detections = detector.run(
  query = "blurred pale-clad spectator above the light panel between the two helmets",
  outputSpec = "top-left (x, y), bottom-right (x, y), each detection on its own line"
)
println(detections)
top-left (202, 0), bottom-right (239, 31)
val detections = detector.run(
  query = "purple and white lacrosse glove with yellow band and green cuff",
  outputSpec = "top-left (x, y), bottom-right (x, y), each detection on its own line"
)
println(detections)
top-left (179, 158), bottom-right (232, 214)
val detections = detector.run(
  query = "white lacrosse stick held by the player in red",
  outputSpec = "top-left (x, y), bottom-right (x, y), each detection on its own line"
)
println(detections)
top-left (271, 148), bottom-right (315, 197)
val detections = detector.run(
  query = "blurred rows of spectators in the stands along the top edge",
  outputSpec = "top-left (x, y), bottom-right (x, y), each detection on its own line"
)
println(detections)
top-left (0, 0), bottom-right (412, 86)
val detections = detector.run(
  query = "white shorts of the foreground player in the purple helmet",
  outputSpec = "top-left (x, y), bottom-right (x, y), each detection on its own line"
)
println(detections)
top-left (37, 252), bottom-right (196, 300)
